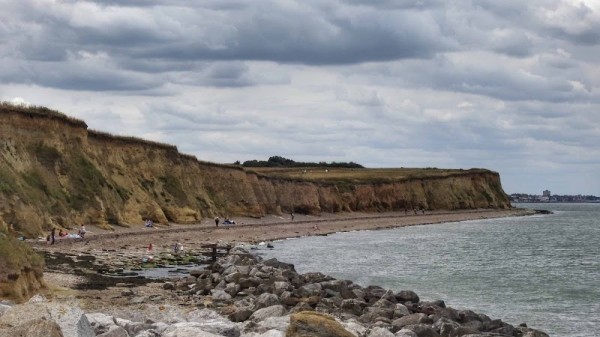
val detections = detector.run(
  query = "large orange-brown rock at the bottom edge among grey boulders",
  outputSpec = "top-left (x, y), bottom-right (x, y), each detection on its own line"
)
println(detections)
top-left (286, 311), bottom-right (354, 337)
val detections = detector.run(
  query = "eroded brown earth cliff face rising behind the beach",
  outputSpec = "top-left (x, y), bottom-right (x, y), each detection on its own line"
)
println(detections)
top-left (0, 107), bottom-right (510, 234)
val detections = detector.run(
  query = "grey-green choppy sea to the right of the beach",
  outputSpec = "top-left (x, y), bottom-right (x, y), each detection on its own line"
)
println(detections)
top-left (260, 203), bottom-right (600, 337)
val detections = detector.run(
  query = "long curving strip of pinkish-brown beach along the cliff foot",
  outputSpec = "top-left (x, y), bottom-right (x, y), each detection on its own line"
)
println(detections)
top-left (39, 209), bottom-right (532, 251)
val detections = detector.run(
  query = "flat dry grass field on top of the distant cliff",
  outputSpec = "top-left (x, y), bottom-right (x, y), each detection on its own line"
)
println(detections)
top-left (249, 167), bottom-right (491, 184)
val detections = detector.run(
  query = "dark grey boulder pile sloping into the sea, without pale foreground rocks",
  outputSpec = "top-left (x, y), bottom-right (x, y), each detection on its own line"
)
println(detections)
top-left (165, 244), bottom-right (546, 337)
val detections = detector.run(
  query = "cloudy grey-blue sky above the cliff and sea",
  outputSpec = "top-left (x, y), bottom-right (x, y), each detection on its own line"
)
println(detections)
top-left (0, 0), bottom-right (600, 196)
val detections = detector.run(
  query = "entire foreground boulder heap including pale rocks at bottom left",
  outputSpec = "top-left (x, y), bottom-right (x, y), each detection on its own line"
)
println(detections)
top-left (0, 248), bottom-right (548, 337)
